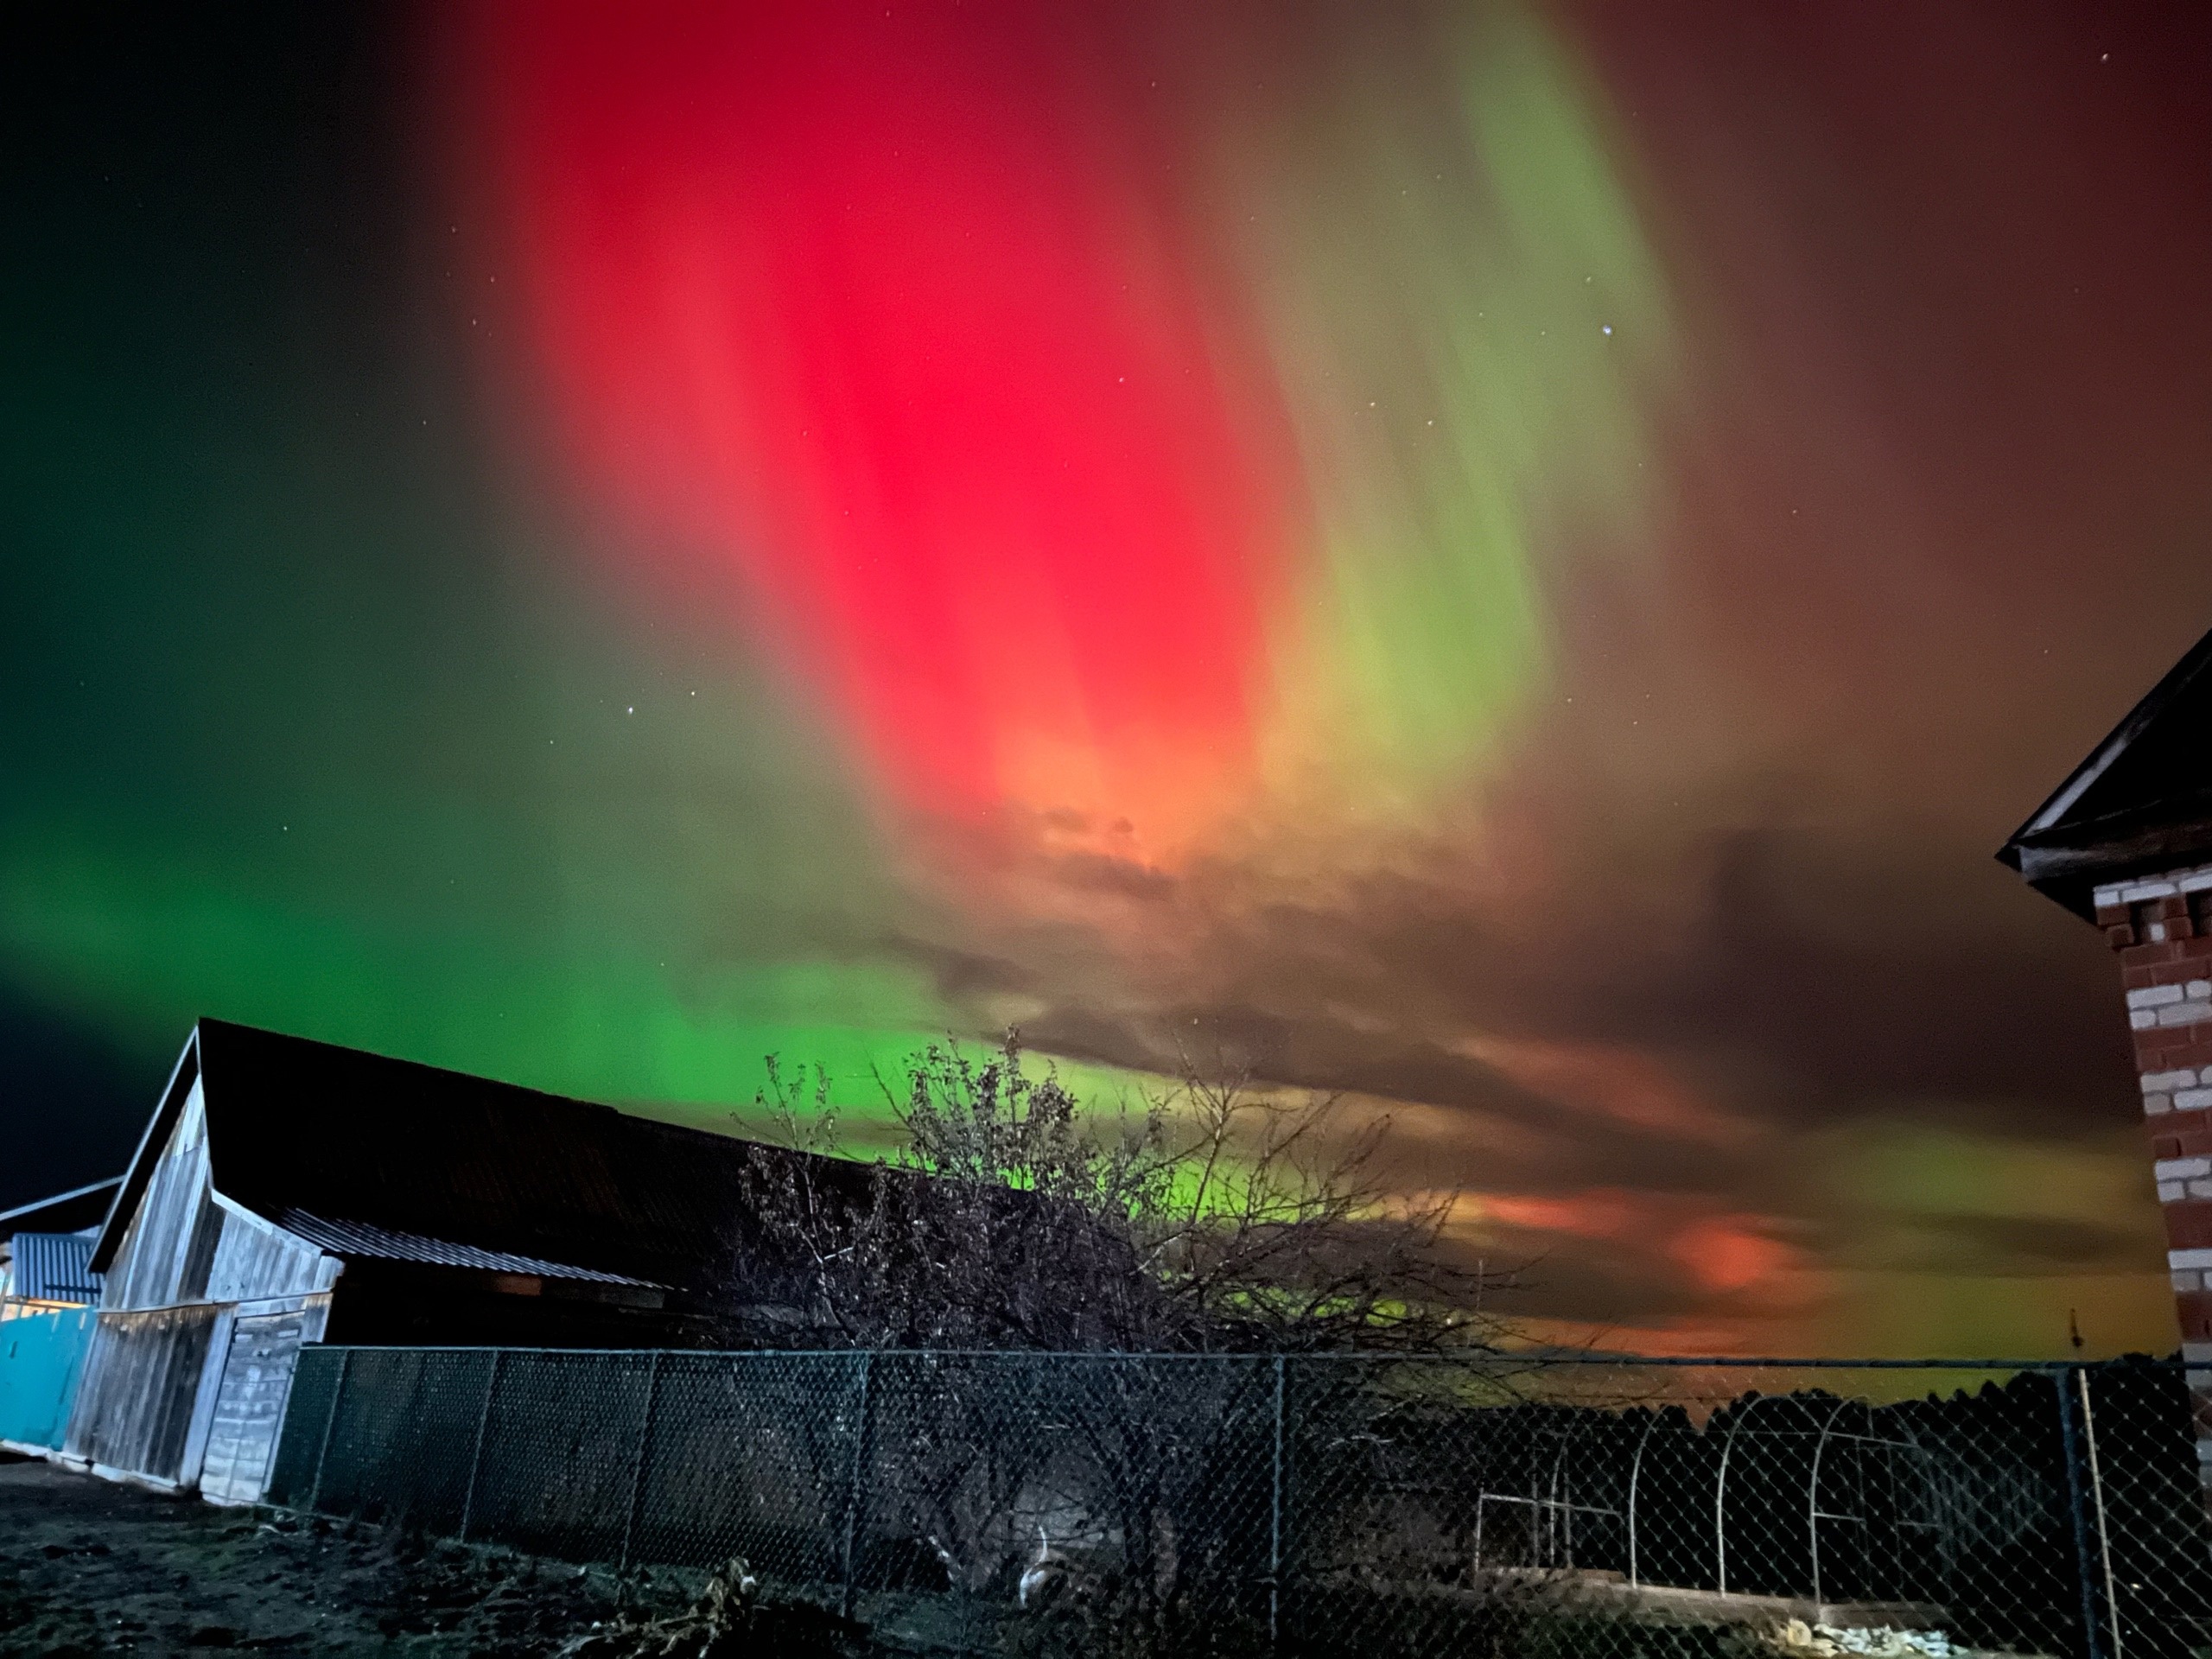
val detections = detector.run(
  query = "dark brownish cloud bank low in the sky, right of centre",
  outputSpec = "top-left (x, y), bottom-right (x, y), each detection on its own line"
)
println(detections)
top-left (909, 757), bottom-right (2148, 1353)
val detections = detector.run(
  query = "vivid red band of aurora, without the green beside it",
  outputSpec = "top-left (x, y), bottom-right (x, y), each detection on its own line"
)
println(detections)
top-left (475, 4), bottom-right (1289, 845)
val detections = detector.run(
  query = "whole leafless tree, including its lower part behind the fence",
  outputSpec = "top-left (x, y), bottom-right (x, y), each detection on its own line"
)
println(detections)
top-left (723, 1035), bottom-right (1497, 1628)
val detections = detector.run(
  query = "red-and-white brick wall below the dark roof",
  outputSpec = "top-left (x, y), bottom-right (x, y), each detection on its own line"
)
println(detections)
top-left (2097, 865), bottom-right (2212, 1489)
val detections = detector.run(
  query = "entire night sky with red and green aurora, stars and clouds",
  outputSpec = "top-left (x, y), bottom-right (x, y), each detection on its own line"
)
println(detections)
top-left (0, 0), bottom-right (2212, 1354)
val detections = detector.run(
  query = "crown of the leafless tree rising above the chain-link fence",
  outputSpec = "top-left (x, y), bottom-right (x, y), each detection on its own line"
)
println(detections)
top-left (730, 1035), bottom-right (1500, 1354)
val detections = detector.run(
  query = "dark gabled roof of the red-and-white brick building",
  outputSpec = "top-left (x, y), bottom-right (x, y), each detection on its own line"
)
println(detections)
top-left (1998, 632), bottom-right (2212, 916)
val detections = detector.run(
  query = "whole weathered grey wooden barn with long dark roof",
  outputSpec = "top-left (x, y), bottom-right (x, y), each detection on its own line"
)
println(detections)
top-left (62, 1020), bottom-right (844, 1502)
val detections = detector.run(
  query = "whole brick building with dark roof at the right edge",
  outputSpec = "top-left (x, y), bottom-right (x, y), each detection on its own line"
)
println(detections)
top-left (1998, 635), bottom-right (2212, 1484)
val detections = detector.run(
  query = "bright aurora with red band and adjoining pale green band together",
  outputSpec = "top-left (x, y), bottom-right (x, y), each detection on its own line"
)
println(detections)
top-left (471, 7), bottom-right (1666, 856)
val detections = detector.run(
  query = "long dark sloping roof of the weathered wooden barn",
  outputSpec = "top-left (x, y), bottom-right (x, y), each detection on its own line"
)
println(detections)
top-left (93, 1020), bottom-right (862, 1289)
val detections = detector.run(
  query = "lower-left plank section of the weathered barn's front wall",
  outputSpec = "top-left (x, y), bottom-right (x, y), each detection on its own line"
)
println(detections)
top-left (62, 1303), bottom-right (230, 1484)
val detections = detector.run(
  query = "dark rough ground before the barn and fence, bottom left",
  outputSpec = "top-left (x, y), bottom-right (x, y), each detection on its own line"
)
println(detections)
top-left (0, 1460), bottom-right (696, 1659)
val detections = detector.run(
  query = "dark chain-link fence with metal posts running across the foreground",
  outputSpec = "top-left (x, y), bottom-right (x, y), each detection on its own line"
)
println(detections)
top-left (270, 1347), bottom-right (2212, 1659)
